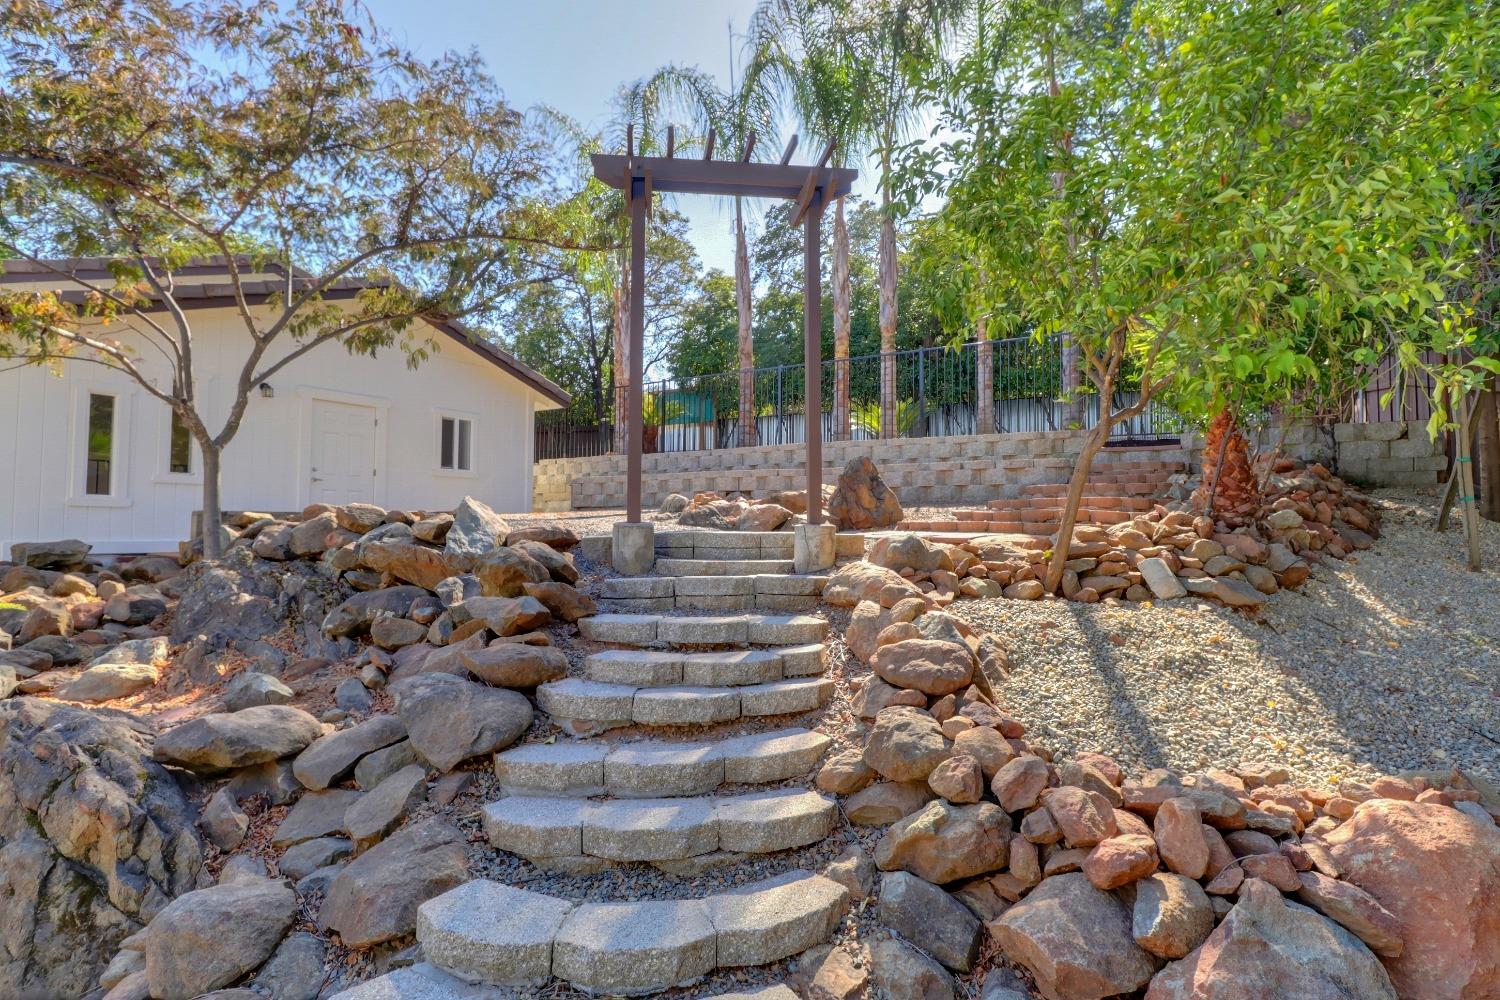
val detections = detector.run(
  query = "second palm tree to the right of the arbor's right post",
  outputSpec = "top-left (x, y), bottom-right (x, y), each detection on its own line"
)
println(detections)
top-left (852, 0), bottom-right (969, 438)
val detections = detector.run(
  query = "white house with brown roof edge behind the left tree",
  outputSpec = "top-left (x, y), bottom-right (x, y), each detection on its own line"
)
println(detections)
top-left (0, 261), bottom-right (569, 553)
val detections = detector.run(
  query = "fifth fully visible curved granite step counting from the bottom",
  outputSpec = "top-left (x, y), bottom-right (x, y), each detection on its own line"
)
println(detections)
top-left (584, 643), bottom-right (828, 688)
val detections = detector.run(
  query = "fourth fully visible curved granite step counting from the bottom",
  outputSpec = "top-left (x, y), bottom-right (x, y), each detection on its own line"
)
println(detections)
top-left (537, 678), bottom-right (834, 733)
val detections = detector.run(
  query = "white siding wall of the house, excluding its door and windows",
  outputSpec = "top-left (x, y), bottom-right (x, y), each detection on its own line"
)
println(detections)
top-left (0, 309), bottom-right (551, 553)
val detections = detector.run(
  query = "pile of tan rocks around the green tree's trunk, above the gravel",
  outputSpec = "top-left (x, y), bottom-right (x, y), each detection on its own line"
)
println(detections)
top-left (866, 465), bottom-right (1380, 607)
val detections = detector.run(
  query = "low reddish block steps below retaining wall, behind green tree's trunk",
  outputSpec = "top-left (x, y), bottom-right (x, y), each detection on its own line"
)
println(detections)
top-left (899, 445), bottom-right (1184, 537)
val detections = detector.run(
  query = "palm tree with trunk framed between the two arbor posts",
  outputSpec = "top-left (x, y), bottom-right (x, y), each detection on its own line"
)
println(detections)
top-left (624, 57), bottom-right (776, 445)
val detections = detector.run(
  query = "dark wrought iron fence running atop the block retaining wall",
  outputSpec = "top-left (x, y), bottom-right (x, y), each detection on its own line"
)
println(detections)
top-left (536, 337), bottom-right (1184, 459)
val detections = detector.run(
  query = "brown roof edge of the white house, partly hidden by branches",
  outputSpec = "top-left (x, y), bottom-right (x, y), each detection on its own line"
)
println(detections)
top-left (0, 256), bottom-right (573, 406)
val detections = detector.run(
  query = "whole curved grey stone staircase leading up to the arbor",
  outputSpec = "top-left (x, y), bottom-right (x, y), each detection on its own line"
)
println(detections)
top-left (341, 532), bottom-right (851, 1000)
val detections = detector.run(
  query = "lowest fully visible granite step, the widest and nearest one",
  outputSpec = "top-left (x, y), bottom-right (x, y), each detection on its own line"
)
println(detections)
top-left (417, 871), bottom-right (849, 997)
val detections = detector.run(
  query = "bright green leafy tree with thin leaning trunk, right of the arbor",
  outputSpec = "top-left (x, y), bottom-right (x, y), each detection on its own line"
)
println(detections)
top-left (908, 0), bottom-right (1500, 592)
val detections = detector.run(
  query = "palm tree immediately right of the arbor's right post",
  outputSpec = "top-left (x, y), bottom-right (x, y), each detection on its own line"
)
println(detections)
top-left (749, 0), bottom-right (873, 438)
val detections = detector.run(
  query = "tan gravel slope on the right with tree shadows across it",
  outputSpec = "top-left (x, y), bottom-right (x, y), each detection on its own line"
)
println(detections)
top-left (953, 490), bottom-right (1500, 783)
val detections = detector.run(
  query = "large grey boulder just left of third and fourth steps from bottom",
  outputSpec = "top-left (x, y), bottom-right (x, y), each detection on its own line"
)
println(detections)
top-left (390, 673), bottom-right (533, 772)
